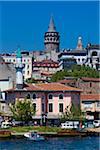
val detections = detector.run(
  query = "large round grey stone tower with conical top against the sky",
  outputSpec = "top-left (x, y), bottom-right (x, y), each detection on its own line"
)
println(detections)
top-left (44, 16), bottom-right (60, 52)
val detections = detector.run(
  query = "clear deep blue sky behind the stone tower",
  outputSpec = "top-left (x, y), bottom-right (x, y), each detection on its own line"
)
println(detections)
top-left (0, 1), bottom-right (99, 53)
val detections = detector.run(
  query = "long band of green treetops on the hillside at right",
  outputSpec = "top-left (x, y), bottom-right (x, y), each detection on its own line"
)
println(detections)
top-left (51, 65), bottom-right (99, 82)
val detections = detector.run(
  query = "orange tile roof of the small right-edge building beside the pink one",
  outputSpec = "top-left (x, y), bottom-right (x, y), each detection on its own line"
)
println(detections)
top-left (81, 94), bottom-right (100, 101)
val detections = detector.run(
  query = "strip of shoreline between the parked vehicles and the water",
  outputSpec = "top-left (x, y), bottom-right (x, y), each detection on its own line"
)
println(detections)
top-left (0, 128), bottom-right (100, 140)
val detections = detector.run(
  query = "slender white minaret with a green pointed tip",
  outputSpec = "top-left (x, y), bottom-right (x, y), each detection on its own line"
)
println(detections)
top-left (15, 48), bottom-right (24, 89)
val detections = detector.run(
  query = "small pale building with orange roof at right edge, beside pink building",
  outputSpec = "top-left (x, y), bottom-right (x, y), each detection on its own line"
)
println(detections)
top-left (81, 94), bottom-right (100, 120)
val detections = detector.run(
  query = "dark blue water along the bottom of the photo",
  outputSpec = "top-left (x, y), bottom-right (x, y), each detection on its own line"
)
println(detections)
top-left (0, 137), bottom-right (99, 150)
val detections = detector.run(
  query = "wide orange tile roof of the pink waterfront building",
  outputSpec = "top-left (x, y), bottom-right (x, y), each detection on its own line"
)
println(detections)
top-left (6, 83), bottom-right (82, 92)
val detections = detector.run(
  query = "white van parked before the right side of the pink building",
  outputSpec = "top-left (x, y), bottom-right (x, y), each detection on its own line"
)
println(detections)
top-left (61, 121), bottom-right (79, 129)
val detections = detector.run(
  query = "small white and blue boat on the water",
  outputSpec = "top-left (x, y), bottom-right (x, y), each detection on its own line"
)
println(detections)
top-left (24, 132), bottom-right (45, 141)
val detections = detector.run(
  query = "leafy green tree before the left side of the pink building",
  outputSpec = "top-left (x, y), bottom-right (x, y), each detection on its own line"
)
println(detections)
top-left (10, 99), bottom-right (36, 123)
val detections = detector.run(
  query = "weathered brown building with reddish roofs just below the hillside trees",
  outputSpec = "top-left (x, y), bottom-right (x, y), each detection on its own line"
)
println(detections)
top-left (59, 77), bottom-right (100, 94)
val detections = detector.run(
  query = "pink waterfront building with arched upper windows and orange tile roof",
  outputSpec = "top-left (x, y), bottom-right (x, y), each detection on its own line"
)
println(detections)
top-left (5, 83), bottom-right (81, 123)
